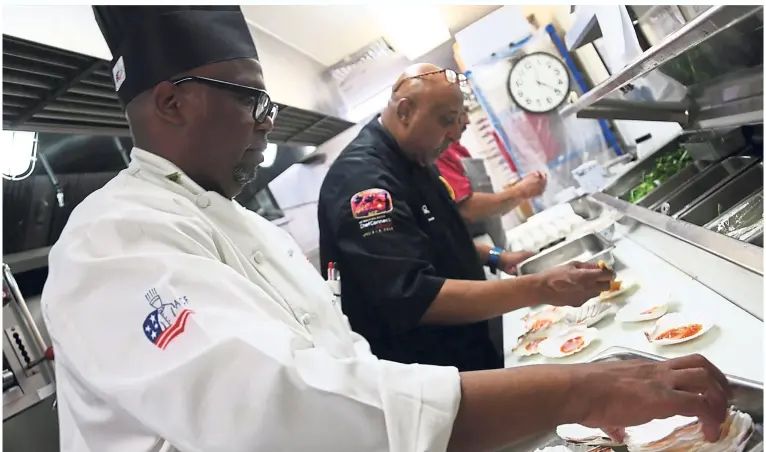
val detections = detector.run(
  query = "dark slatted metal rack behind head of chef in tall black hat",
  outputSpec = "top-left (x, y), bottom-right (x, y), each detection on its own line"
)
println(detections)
top-left (3, 35), bottom-right (353, 146)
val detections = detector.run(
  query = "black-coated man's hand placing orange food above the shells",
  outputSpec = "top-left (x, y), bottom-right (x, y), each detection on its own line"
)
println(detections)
top-left (537, 262), bottom-right (614, 306)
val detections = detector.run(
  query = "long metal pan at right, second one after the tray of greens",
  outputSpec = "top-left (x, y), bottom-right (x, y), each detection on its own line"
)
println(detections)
top-left (678, 162), bottom-right (763, 226)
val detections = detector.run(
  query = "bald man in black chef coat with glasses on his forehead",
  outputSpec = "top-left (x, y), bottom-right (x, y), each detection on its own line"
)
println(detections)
top-left (318, 64), bottom-right (612, 371)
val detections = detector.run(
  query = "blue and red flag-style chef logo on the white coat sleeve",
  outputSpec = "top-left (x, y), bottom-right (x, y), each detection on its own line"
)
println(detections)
top-left (144, 289), bottom-right (194, 350)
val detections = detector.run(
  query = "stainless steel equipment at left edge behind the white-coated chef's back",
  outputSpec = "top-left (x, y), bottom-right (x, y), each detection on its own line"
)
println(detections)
top-left (3, 264), bottom-right (55, 421)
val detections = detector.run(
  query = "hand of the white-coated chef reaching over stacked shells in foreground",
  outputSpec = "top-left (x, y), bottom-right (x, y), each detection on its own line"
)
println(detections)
top-left (572, 355), bottom-right (732, 442)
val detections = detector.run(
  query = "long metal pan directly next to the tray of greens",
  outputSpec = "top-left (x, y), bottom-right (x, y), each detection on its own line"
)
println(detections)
top-left (649, 157), bottom-right (758, 217)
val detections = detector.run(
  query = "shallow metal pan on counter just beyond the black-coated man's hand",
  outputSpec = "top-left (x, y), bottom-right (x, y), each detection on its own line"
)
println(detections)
top-left (518, 233), bottom-right (614, 276)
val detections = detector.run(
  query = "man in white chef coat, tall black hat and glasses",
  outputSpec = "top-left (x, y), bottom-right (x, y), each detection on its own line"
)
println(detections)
top-left (42, 6), bottom-right (728, 452)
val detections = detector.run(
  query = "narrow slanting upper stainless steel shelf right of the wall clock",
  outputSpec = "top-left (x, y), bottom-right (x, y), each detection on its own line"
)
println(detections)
top-left (560, 5), bottom-right (763, 117)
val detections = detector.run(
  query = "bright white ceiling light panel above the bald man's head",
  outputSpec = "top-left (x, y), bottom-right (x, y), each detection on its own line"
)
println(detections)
top-left (373, 5), bottom-right (452, 61)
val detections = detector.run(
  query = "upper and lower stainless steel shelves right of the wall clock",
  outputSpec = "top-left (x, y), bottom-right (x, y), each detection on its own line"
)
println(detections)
top-left (560, 5), bottom-right (763, 131)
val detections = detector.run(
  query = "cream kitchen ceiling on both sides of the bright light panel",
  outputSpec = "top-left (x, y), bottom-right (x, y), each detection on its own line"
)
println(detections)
top-left (242, 5), bottom-right (500, 66)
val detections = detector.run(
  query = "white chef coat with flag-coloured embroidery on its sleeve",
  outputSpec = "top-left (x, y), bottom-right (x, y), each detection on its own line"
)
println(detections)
top-left (42, 149), bottom-right (460, 452)
